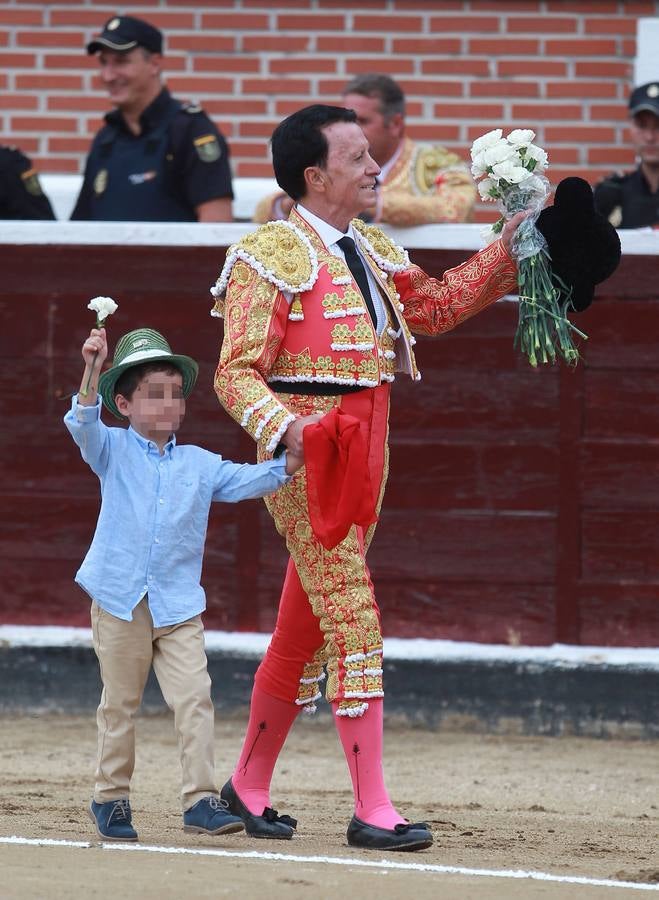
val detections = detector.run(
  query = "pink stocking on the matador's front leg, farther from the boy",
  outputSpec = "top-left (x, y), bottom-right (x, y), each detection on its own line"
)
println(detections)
top-left (332, 697), bottom-right (407, 829)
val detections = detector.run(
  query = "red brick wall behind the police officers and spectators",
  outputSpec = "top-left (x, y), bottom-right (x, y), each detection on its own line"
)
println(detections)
top-left (0, 0), bottom-right (659, 219)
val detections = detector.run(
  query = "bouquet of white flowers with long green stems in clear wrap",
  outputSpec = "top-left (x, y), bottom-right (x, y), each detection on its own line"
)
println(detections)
top-left (471, 128), bottom-right (586, 366)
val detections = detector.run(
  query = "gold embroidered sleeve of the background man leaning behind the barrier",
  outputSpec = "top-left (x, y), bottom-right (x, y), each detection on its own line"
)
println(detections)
top-left (380, 170), bottom-right (476, 228)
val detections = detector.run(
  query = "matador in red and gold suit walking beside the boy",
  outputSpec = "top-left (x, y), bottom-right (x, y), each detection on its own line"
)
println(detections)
top-left (212, 105), bottom-right (517, 850)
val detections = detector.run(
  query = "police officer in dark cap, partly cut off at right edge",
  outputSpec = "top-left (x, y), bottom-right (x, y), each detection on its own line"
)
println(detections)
top-left (593, 81), bottom-right (659, 228)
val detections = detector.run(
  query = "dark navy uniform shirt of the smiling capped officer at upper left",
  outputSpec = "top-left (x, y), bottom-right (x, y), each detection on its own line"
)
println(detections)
top-left (71, 88), bottom-right (233, 222)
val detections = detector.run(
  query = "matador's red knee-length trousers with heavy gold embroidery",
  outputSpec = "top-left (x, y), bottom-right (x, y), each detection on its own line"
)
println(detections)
top-left (255, 384), bottom-right (390, 716)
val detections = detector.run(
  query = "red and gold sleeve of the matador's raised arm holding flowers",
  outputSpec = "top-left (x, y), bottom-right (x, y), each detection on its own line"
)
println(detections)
top-left (394, 240), bottom-right (517, 335)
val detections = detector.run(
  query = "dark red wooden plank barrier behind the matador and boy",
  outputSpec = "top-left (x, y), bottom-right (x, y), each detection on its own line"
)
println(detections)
top-left (0, 246), bottom-right (659, 646)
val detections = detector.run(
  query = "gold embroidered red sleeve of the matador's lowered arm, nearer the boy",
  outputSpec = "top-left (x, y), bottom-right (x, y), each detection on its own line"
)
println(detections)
top-left (214, 260), bottom-right (295, 453)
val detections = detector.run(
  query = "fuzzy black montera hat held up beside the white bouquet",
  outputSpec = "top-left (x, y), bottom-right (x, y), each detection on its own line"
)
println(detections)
top-left (536, 178), bottom-right (621, 312)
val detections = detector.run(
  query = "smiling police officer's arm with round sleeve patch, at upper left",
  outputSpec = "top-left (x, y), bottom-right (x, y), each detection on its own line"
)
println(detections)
top-left (172, 106), bottom-right (233, 222)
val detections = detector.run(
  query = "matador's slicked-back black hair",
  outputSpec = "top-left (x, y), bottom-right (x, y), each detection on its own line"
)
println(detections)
top-left (270, 103), bottom-right (357, 200)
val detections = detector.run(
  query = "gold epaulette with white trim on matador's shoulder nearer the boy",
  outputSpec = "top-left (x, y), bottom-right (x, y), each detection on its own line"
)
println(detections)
top-left (211, 222), bottom-right (318, 298)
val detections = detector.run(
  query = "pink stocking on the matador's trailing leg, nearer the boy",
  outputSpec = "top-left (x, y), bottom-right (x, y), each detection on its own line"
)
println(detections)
top-left (231, 685), bottom-right (300, 816)
